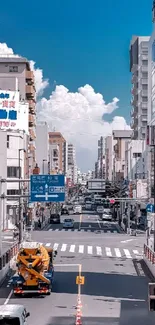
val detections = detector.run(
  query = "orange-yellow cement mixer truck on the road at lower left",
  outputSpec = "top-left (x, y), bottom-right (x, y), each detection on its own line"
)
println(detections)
top-left (10, 242), bottom-right (57, 296)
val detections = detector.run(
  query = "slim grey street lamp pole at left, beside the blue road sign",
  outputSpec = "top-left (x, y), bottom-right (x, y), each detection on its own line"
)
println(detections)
top-left (18, 148), bottom-right (26, 243)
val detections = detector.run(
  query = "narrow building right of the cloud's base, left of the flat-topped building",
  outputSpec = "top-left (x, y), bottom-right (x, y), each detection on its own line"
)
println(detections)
top-left (105, 135), bottom-right (116, 181)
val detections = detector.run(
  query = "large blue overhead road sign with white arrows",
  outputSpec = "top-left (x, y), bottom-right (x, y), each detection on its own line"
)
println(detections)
top-left (31, 175), bottom-right (65, 202)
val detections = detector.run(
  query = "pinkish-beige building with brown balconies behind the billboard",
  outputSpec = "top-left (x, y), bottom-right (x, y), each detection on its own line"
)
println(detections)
top-left (0, 54), bottom-right (36, 174)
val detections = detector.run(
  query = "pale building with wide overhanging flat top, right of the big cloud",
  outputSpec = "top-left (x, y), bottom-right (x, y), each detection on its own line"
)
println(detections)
top-left (112, 130), bottom-right (133, 181)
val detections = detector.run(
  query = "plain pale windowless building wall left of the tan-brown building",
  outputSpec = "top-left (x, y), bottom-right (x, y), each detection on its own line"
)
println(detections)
top-left (36, 122), bottom-right (49, 174)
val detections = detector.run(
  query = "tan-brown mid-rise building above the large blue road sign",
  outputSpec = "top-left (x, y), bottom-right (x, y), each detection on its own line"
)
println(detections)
top-left (49, 131), bottom-right (68, 175)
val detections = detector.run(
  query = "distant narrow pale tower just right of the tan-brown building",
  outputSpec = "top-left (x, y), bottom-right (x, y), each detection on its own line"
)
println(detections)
top-left (68, 143), bottom-right (77, 184)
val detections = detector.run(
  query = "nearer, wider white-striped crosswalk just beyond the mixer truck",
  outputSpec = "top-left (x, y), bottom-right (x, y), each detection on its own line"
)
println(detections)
top-left (40, 243), bottom-right (143, 259)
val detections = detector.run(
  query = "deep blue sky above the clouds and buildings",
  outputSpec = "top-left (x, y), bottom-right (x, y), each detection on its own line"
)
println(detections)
top-left (0, 0), bottom-right (153, 170)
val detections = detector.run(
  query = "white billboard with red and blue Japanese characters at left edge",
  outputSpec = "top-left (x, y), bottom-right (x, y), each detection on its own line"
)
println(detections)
top-left (0, 90), bottom-right (28, 133)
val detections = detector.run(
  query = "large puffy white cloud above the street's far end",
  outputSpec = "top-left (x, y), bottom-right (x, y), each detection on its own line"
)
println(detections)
top-left (37, 85), bottom-right (130, 167)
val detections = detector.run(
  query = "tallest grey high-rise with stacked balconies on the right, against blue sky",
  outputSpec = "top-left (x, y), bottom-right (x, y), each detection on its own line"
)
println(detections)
top-left (130, 36), bottom-right (150, 140)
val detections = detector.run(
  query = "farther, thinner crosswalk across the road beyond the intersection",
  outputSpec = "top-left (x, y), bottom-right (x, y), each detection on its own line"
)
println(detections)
top-left (48, 227), bottom-right (119, 234)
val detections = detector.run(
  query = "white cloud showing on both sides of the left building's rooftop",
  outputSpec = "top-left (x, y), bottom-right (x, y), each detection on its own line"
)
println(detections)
top-left (0, 43), bottom-right (49, 97)
